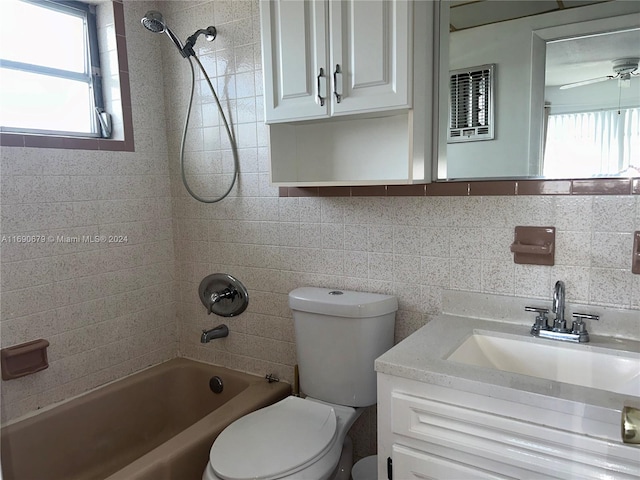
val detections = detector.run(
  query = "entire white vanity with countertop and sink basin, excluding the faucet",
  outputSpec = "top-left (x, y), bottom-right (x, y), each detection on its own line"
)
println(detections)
top-left (376, 291), bottom-right (640, 480)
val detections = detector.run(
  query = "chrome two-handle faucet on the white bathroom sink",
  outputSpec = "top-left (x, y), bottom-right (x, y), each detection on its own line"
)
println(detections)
top-left (525, 280), bottom-right (600, 343)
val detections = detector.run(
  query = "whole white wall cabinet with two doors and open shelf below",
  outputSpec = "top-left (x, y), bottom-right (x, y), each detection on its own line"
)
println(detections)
top-left (260, 0), bottom-right (436, 186)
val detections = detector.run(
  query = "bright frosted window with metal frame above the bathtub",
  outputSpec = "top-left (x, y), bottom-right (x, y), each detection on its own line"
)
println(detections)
top-left (0, 0), bottom-right (111, 137)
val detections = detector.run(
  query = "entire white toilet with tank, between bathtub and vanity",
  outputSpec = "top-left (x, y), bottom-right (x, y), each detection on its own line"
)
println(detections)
top-left (202, 287), bottom-right (398, 480)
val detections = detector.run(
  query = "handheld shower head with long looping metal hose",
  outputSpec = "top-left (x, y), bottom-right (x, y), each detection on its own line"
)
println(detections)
top-left (140, 10), bottom-right (240, 203)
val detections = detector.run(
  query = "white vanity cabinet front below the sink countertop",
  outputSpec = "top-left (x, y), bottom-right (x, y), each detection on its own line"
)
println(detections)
top-left (378, 373), bottom-right (640, 480)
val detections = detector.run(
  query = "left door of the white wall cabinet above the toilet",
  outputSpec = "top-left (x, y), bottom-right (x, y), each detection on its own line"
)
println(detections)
top-left (260, 0), bottom-right (329, 123)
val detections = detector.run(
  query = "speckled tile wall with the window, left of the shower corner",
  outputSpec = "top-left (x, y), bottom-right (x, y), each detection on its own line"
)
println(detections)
top-left (0, 2), bottom-right (177, 421)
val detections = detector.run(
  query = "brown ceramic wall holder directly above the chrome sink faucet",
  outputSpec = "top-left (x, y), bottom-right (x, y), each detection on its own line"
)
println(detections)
top-left (511, 226), bottom-right (556, 265)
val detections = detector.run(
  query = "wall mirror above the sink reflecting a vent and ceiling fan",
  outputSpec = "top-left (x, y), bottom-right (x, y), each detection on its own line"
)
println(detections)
top-left (435, 0), bottom-right (640, 181)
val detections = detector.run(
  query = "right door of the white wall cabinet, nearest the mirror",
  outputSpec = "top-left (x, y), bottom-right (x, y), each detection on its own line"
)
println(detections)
top-left (329, 0), bottom-right (413, 115)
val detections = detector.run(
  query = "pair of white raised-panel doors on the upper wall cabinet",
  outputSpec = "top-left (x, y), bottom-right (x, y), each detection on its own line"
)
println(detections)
top-left (260, 0), bottom-right (413, 123)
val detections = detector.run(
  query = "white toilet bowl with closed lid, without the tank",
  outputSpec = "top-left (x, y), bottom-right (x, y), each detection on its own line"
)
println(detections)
top-left (202, 396), bottom-right (362, 480)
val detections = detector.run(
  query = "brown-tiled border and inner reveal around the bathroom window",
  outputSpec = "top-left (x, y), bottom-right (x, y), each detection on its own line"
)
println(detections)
top-left (0, 0), bottom-right (135, 152)
